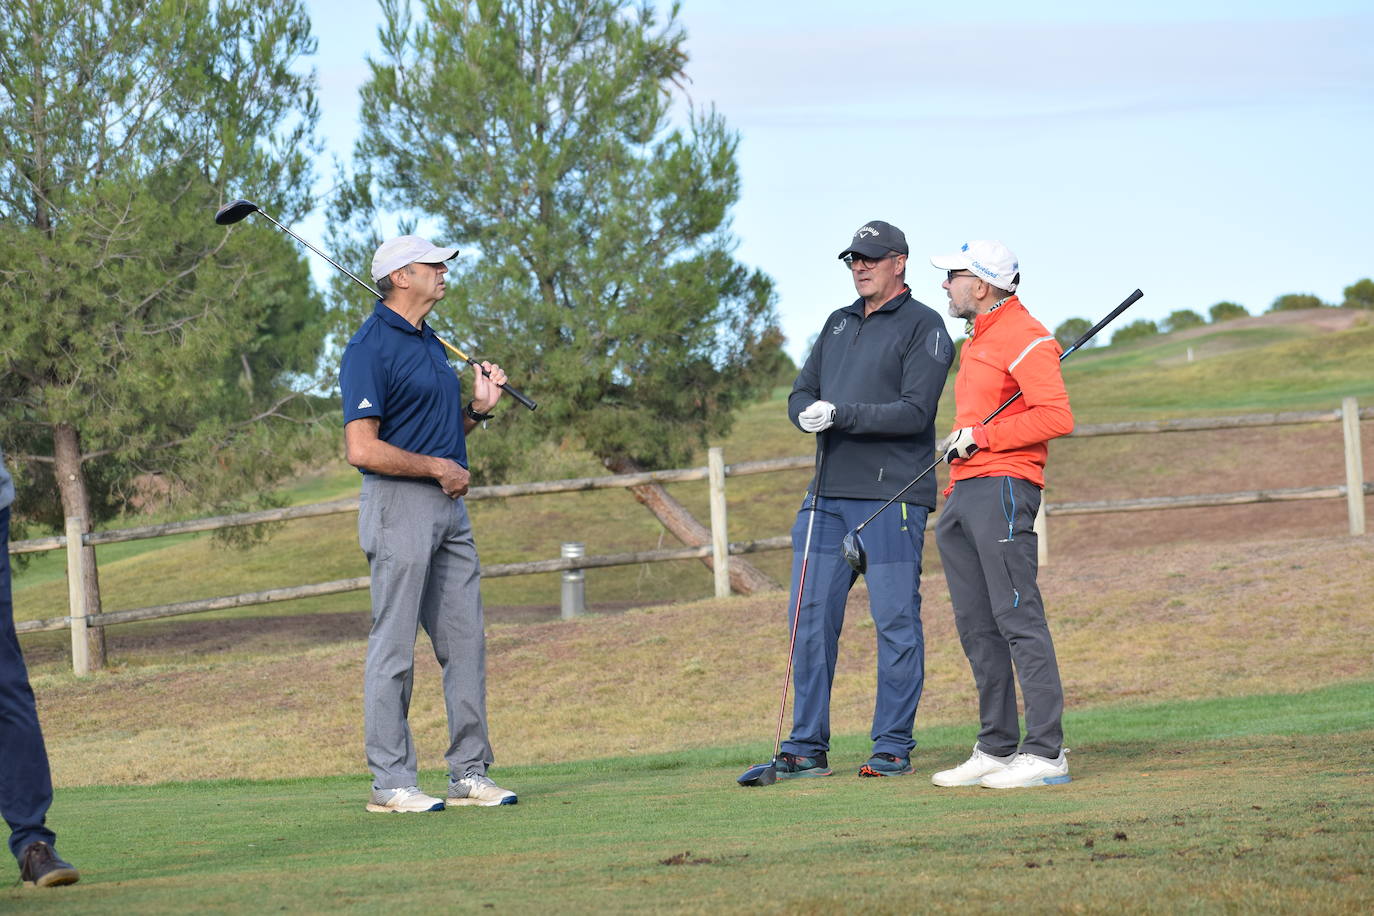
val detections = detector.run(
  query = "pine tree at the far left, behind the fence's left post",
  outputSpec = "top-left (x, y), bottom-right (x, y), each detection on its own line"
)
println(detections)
top-left (0, 0), bottom-right (332, 658)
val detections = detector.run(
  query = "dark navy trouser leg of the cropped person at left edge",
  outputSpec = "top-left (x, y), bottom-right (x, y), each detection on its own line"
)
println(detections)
top-left (0, 505), bottom-right (56, 858)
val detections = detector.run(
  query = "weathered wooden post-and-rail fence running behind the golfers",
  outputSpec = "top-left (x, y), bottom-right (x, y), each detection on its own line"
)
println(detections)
top-left (10, 398), bottom-right (1374, 674)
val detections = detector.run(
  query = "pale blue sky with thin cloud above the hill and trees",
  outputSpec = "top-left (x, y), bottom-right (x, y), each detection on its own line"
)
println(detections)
top-left (301, 0), bottom-right (1374, 360)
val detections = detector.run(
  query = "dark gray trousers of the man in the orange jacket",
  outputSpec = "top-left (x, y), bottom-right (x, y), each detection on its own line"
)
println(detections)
top-left (936, 477), bottom-right (1063, 758)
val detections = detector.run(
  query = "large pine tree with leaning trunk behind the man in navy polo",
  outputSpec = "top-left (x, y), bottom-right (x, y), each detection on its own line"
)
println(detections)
top-left (331, 0), bottom-right (782, 588)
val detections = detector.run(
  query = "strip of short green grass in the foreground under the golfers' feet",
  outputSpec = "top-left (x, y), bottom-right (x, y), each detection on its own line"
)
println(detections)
top-left (13, 683), bottom-right (1374, 913)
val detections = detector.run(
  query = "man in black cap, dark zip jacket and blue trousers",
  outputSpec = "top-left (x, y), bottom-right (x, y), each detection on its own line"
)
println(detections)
top-left (776, 220), bottom-right (954, 779)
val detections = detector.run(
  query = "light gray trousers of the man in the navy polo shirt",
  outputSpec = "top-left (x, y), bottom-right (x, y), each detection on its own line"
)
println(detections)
top-left (357, 474), bottom-right (492, 788)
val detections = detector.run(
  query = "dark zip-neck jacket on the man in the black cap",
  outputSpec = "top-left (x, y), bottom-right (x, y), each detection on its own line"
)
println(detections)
top-left (787, 288), bottom-right (954, 508)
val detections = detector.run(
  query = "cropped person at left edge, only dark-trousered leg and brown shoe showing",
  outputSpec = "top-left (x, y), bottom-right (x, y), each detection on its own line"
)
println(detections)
top-left (0, 452), bottom-right (81, 887)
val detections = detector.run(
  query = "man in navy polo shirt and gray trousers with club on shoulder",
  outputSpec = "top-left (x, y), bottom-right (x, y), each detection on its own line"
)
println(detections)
top-left (339, 235), bottom-right (517, 812)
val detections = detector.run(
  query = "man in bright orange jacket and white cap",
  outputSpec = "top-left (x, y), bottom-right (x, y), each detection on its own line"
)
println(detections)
top-left (930, 242), bottom-right (1073, 788)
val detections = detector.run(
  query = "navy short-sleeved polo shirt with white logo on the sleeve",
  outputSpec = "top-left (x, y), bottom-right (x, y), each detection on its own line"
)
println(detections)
top-left (339, 301), bottom-right (467, 474)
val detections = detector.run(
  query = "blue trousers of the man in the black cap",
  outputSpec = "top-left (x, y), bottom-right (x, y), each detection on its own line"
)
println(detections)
top-left (782, 494), bottom-right (930, 757)
